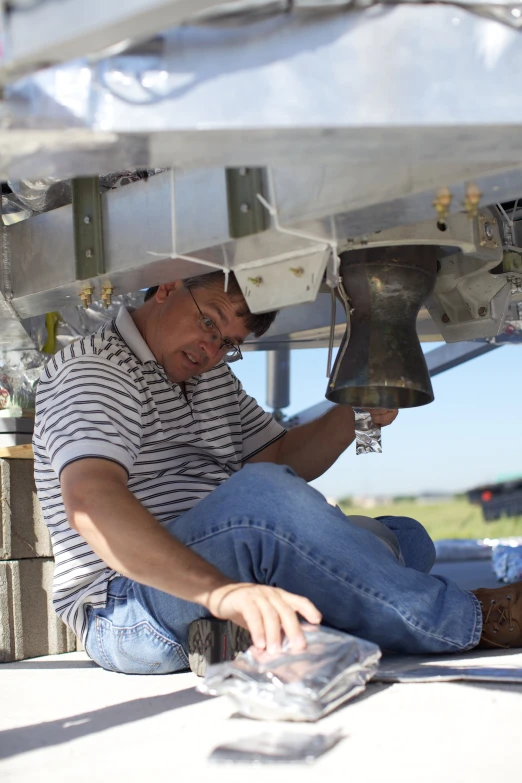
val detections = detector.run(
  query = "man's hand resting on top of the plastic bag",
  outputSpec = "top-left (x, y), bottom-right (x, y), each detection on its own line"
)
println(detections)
top-left (206, 582), bottom-right (321, 652)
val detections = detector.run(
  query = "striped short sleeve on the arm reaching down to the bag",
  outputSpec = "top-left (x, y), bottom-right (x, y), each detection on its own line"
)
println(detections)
top-left (35, 355), bottom-right (141, 475)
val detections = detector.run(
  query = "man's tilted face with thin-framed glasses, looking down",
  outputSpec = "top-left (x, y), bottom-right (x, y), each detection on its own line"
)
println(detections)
top-left (136, 280), bottom-right (249, 383)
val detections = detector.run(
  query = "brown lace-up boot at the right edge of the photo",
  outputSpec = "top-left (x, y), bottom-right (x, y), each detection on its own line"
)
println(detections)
top-left (471, 582), bottom-right (522, 649)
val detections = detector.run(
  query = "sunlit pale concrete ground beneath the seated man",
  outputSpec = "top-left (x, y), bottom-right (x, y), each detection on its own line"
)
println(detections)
top-left (0, 562), bottom-right (522, 783)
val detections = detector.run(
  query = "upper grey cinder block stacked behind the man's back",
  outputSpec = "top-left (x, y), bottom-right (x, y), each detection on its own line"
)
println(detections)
top-left (0, 459), bottom-right (52, 560)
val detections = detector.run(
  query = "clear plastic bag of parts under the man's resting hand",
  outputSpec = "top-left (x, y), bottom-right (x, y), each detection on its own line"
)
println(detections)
top-left (197, 624), bottom-right (381, 721)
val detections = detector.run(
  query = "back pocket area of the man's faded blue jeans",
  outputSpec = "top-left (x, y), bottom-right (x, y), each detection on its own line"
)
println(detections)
top-left (88, 615), bottom-right (188, 674)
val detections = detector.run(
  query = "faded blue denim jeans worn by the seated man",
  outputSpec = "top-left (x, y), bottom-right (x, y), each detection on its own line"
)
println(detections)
top-left (86, 463), bottom-right (482, 674)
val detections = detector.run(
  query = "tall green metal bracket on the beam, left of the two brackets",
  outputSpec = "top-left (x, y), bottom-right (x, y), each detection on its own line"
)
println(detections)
top-left (72, 177), bottom-right (105, 280)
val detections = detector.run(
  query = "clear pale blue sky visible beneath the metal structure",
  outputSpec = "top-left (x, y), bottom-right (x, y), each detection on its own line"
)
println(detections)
top-left (234, 344), bottom-right (522, 498)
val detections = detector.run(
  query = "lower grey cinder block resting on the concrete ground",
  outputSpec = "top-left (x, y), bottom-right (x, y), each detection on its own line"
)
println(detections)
top-left (0, 558), bottom-right (76, 663)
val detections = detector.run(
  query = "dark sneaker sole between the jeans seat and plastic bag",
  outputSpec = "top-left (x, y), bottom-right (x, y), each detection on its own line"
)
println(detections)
top-left (188, 617), bottom-right (252, 677)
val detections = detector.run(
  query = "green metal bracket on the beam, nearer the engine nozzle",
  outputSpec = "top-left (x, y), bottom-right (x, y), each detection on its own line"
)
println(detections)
top-left (226, 168), bottom-right (269, 239)
